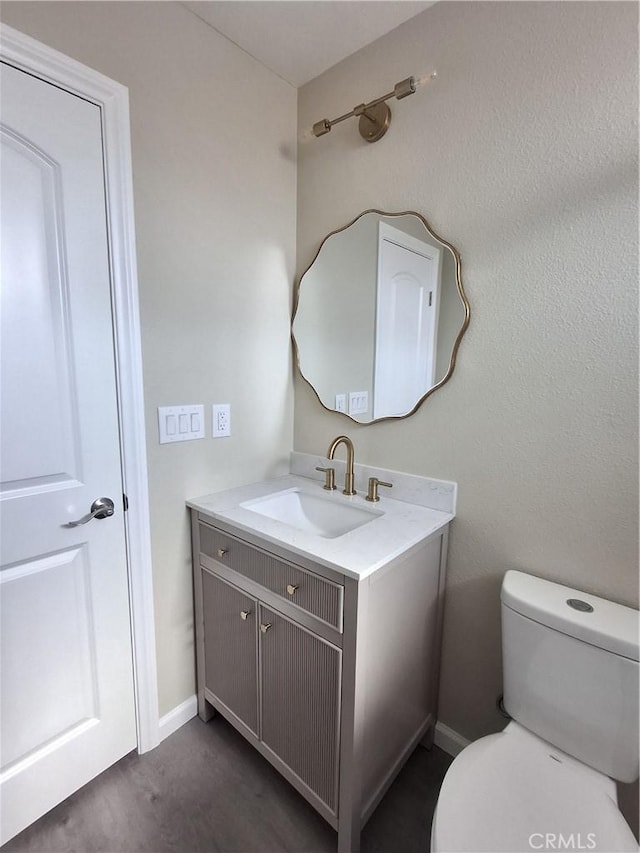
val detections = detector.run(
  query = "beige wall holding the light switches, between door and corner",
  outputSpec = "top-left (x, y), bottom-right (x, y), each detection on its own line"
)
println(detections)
top-left (1, 2), bottom-right (296, 714)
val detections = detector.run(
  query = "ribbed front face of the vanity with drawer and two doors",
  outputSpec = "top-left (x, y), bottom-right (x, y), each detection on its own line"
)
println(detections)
top-left (194, 523), bottom-right (343, 822)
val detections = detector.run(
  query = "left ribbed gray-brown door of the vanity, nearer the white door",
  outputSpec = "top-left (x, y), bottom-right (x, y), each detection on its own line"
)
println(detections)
top-left (202, 571), bottom-right (258, 735)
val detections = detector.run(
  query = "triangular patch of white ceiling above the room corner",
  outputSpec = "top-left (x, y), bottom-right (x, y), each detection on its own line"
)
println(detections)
top-left (183, 0), bottom-right (433, 88)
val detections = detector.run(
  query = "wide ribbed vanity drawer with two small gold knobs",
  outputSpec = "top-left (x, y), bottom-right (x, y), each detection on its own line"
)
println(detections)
top-left (200, 524), bottom-right (343, 631)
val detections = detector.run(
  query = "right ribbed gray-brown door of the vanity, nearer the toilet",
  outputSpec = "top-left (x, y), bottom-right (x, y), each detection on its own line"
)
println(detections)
top-left (260, 605), bottom-right (342, 813)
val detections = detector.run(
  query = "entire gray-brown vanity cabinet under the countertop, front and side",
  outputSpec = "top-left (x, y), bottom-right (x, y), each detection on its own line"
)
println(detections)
top-left (192, 509), bottom-right (447, 853)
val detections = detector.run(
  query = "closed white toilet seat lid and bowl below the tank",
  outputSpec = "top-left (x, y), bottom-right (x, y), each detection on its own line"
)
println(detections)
top-left (431, 723), bottom-right (638, 853)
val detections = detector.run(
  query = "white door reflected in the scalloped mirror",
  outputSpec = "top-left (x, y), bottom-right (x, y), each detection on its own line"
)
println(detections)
top-left (373, 222), bottom-right (442, 418)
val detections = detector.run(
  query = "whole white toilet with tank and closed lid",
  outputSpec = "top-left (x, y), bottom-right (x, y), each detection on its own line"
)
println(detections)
top-left (431, 571), bottom-right (639, 853)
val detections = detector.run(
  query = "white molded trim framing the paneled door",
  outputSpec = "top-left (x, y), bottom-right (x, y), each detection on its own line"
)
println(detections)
top-left (0, 24), bottom-right (160, 753)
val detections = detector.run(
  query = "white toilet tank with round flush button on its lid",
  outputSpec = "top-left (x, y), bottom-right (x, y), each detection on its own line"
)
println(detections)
top-left (500, 571), bottom-right (639, 782)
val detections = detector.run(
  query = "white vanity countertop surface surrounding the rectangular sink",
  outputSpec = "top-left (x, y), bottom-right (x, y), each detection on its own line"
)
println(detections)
top-left (187, 474), bottom-right (454, 580)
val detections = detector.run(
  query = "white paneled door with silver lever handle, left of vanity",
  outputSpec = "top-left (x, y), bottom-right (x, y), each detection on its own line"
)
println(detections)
top-left (0, 63), bottom-right (136, 842)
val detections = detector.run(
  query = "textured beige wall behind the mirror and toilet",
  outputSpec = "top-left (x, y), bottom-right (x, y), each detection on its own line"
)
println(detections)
top-left (295, 2), bottom-right (638, 738)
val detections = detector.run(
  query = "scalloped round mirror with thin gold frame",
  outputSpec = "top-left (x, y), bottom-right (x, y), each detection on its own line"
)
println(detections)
top-left (292, 210), bottom-right (469, 424)
